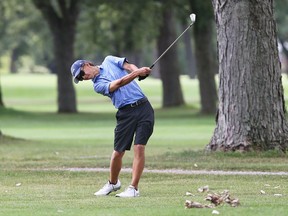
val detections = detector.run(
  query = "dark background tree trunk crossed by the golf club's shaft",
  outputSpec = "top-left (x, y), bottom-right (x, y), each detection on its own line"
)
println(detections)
top-left (157, 7), bottom-right (184, 107)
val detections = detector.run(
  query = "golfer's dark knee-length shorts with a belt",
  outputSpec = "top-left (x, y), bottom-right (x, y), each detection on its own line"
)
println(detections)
top-left (114, 101), bottom-right (154, 152)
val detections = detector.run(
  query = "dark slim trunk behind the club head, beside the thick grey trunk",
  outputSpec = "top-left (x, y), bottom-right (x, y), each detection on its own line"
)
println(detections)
top-left (190, 0), bottom-right (218, 114)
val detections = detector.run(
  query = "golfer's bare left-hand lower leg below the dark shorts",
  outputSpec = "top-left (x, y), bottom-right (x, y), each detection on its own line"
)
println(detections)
top-left (110, 151), bottom-right (125, 184)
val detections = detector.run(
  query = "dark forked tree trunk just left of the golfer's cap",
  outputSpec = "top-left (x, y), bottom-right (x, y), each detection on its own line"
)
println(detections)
top-left (33, 0), bottom-right (79, 113)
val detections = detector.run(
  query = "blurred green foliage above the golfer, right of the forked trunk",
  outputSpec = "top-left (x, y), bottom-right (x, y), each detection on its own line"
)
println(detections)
top-left (76, 1), bottom-right (158, 59)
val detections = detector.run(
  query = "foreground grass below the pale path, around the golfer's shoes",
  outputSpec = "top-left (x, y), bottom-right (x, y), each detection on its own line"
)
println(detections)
top-left (0, 170), bottom-right (288, 216)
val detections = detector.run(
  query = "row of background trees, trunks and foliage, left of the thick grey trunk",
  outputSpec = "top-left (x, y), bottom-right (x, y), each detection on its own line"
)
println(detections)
top-left (0, 0), bottom-right (231, 114)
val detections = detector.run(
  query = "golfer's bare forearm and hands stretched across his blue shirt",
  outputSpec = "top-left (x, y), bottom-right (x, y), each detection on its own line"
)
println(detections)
top-left (109, 66), bottom-right (151, 92)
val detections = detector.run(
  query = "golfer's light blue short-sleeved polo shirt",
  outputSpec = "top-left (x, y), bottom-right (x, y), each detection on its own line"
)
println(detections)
top-left (92, 56), bottom-right (145, 109)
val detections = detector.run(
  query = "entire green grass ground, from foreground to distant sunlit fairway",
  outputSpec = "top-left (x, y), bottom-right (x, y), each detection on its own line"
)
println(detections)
top-left (0, 74), bottom-right (288, 216)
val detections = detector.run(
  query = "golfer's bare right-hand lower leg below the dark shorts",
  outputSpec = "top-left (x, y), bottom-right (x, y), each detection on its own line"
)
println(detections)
top-left (131, 145), bottom-right (145, 189)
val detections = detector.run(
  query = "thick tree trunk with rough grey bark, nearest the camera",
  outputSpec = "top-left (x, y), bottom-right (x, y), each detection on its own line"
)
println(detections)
top-left (207, 0), bottom-right (288, 152)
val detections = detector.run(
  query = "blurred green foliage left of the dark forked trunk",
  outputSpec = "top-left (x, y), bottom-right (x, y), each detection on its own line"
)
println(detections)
top-left (0, 0), bottom-right (52, 72)
